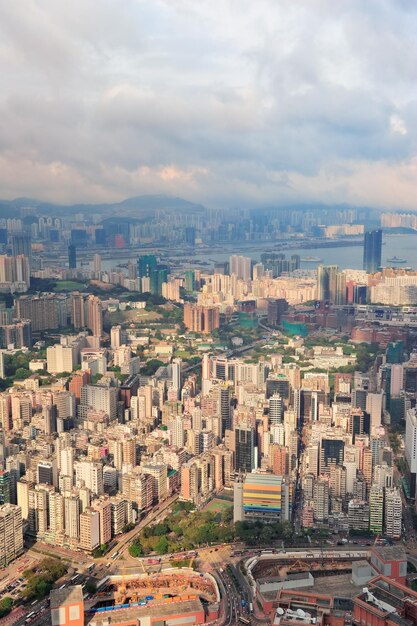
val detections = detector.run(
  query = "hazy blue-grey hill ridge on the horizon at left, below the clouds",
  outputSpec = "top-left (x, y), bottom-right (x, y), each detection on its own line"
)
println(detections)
top-left (0, 195), bottom-right (207, 219)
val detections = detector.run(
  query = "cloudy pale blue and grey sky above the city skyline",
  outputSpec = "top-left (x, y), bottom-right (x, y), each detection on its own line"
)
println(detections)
top-left (0, 0), bottom-right (417, 210)
